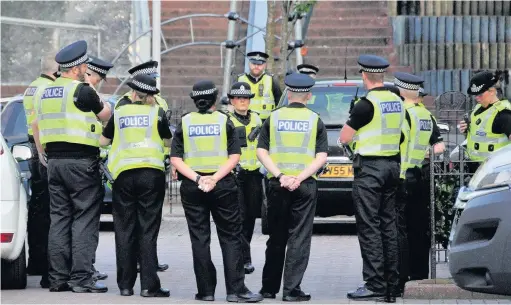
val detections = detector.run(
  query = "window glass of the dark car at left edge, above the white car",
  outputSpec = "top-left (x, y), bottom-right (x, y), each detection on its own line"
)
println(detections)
top-left (0, 101), bottom-right (27, 141)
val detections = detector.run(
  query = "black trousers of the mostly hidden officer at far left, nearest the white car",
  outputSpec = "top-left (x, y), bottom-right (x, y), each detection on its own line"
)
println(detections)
top-left (27, 144), bottom-right (50, 278)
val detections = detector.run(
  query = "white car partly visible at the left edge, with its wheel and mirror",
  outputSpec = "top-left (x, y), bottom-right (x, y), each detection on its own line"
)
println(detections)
top-left (0, 134), bottom-right (32, 289)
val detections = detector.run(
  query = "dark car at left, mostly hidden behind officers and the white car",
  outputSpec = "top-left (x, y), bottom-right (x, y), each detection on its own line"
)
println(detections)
top-left (1, 95), bottom-right (116, 214)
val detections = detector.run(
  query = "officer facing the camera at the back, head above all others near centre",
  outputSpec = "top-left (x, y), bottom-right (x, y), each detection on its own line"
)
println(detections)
top-left (238, 51), bottom-right (282, 121)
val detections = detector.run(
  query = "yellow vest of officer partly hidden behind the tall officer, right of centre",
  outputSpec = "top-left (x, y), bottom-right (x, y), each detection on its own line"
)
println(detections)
top-left (401, 103), bottom-right (433, 179)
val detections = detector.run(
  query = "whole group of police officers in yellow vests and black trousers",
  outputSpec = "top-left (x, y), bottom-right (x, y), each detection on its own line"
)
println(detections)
top-left (24, 36), bottom-right (511, 302)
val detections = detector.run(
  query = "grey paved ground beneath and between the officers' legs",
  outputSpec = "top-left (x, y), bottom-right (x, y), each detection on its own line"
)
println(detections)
top-left (1, 198), bottom-right (511, 304)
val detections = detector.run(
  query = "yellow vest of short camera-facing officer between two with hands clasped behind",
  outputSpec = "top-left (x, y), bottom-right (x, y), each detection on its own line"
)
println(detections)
top-left (229, 112), bottom-right (262, 171)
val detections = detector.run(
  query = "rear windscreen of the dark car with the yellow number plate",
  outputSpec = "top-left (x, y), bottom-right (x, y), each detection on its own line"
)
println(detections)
top-left (280, 86), bottom-right (366, 126)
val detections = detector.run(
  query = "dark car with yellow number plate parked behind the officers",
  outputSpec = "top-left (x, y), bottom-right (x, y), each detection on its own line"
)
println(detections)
top-left (270, 79), bottom-right (398, 217)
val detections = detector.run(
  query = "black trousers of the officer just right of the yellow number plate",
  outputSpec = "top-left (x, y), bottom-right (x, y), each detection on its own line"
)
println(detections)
top-left (353, 157), bottom-right (399, 293)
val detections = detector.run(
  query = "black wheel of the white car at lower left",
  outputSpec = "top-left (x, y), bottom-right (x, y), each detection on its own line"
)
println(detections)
top-left (2, 246), bottom-right (27, 289)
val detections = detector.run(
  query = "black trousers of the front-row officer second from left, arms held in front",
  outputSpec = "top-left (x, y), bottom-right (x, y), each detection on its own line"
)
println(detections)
top-left (112, 168), bottom-right (165, 291)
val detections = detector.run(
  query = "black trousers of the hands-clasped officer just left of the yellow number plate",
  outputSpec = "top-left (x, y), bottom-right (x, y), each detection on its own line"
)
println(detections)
top-left (262, 178), bottom-right (317, 296)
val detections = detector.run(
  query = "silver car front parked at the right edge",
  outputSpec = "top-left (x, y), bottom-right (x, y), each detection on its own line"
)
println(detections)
top-left (449, 145), bottom-right (511, 295)
